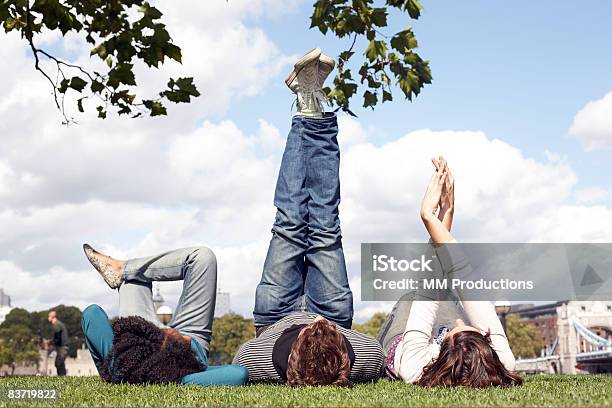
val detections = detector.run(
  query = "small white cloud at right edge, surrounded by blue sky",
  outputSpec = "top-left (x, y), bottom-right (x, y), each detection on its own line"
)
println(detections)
top-left (569, 92), bottom-right (612, 150)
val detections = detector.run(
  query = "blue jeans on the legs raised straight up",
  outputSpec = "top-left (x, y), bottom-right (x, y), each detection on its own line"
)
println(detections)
top-left (253, 113), bottom-right (353, 328)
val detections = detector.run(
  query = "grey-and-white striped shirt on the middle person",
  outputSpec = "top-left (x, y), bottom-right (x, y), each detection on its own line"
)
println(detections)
top-left (232, 312), bottom-right (385, 382)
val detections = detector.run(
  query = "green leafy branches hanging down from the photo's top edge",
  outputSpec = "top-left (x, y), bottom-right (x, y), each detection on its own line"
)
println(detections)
top-left (0, 0), bottom-right (432, 123)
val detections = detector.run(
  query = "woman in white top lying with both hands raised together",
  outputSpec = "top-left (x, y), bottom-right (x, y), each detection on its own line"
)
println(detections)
top-left (378, 157), bottom-right (522, 388)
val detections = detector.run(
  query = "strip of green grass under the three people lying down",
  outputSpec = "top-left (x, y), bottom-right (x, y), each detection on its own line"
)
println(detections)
top-left (0, 375), bottom-right (612, 407)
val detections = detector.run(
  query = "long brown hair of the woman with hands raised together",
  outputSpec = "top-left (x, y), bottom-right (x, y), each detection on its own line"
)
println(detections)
top-left (416, 331), bottom-right (523, 388)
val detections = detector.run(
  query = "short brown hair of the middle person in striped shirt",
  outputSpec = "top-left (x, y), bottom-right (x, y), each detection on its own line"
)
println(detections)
top-left (287, 320), bottom-right (351, 386)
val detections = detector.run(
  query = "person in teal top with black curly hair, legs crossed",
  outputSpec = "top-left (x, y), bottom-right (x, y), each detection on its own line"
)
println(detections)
top-left (81, 244), bottom-right (248, 385)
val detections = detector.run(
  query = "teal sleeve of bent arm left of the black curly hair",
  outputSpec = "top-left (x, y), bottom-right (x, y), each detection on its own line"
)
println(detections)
top-left (81, 305), bottom-right (113, 373)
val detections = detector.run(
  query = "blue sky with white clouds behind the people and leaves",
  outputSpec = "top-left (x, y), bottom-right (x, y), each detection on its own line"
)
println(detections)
top-left (0, 0), bottom-right (612, 320)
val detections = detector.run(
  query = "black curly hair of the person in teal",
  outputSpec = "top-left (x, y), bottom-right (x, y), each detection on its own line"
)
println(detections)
top-left (100, 316), bottom-right (203, 384)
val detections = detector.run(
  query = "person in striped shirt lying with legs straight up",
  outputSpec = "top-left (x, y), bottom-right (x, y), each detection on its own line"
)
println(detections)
top-left (234, 48), bottom-right (384, 386)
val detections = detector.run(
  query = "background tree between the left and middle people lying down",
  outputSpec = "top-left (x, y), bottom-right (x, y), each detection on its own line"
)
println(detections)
top-left (210, 313), bottom-right (255, 364)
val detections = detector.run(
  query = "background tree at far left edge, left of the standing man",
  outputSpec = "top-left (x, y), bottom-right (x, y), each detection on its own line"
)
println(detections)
top-left (0, 325), bottom-right (40, 375)
